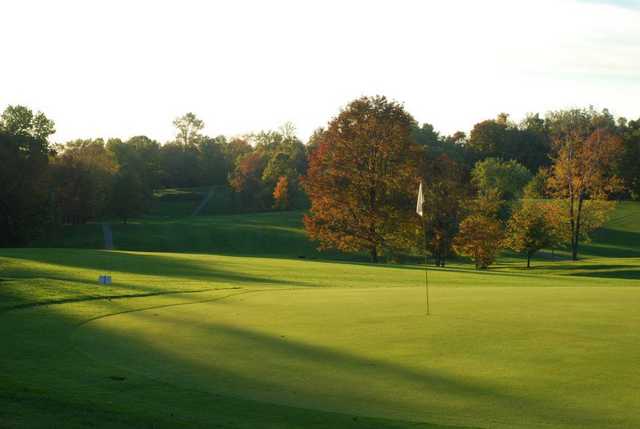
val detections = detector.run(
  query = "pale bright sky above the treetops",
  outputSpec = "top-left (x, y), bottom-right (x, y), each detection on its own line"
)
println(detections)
top-left (0, 0), bottom-right (640, 142)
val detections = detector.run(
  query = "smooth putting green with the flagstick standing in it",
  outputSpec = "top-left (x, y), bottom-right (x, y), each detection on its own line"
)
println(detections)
top-left (72, 286), bottom-right (640, 428)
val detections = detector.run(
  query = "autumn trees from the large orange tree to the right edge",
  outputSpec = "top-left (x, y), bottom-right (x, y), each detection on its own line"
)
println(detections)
top-left (303, 97), bottom-right (640, 269)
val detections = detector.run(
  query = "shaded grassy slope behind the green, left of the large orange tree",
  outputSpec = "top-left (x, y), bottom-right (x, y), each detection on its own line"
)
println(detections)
top-left (35, 208), bottom-right (348, 260)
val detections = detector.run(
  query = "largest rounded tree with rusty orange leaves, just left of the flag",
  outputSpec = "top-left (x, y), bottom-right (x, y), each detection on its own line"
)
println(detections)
top-left (303, 96), bottom-right (419, 262)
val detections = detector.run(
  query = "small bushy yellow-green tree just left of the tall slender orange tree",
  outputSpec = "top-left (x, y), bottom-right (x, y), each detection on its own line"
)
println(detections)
top-left (504, 200), bottom-right (560, 268)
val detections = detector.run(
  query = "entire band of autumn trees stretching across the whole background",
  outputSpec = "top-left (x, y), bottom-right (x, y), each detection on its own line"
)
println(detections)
top-left (0, 97), bottom-right (640, 268)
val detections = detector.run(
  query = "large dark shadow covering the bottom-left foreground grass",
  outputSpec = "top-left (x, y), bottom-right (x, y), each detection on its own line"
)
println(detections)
top-left (0, 294), bottom-right (471, 429)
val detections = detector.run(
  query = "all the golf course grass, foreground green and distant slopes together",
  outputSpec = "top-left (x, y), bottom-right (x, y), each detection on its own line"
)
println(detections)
top-left (0, 203), bottom-right (640, 429)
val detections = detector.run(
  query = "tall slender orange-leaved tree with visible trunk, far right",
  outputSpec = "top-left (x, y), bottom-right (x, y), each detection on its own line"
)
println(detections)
top-left (548, 109), bottom-right (623, 260)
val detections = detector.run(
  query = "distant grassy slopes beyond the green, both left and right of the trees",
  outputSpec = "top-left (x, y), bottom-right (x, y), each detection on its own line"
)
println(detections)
top-left (33, 189), bottom-right (640, 261)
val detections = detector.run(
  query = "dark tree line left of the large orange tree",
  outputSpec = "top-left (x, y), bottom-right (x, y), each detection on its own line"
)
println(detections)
top-left (0, 106), bottom-right (311, 246)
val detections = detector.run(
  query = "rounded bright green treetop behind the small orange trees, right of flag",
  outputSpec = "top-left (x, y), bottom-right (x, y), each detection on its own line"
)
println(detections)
top-left (471, 158), bottom-right (532, 200)
